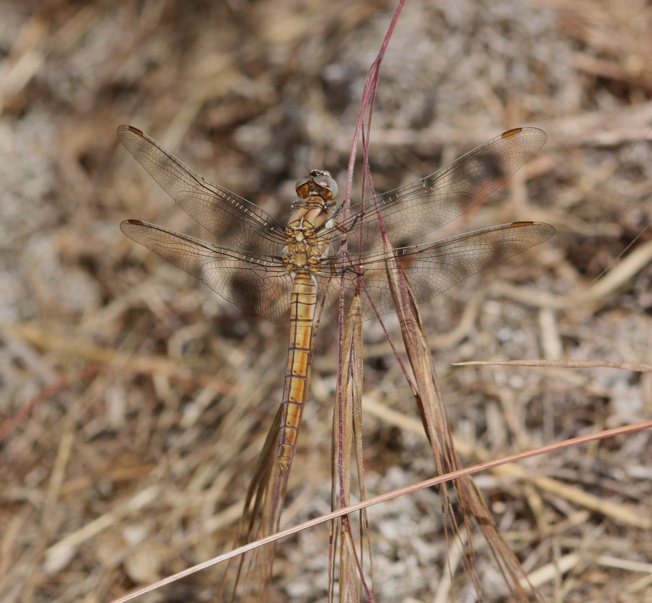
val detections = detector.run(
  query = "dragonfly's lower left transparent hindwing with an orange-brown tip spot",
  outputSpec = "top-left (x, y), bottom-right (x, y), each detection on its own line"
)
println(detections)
top-left (120, 220), bottom-right (292, 323)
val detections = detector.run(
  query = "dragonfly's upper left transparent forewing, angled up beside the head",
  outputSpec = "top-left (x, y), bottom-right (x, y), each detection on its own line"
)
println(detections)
top-left (118, 126), bottom-right (284, 255)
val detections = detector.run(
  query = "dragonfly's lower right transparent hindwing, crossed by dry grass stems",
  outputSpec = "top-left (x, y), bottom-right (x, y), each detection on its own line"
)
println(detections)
top-left (320, 222), bottom-right (555, 319)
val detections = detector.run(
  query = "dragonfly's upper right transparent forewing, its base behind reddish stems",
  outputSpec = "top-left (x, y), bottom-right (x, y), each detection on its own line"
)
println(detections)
top-left (333, 128), bottom-right (546, 253)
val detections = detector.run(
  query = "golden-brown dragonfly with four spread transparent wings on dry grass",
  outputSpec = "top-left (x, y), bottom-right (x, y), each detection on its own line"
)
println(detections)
top-left (118, 125), bottom-right (555, 474)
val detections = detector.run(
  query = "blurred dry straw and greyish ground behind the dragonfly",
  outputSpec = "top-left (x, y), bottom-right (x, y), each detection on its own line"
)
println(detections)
top-left (0, 0), bottom-right (652, 602)
